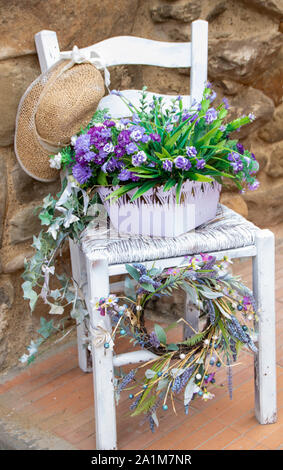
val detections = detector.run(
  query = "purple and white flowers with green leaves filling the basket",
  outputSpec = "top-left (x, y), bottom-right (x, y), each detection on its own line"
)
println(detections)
top-left (50, 84), bottom-right (259, 201)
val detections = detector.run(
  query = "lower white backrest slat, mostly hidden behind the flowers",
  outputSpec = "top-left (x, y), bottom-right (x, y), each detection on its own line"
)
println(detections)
top-left (98, 90), bottom-right (190, 118)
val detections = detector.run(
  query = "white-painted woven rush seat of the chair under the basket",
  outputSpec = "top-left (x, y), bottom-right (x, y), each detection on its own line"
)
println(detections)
top-left (81, 204), bottom-right (259, 265)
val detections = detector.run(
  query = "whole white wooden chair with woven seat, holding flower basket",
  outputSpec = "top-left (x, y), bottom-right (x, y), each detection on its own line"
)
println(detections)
top-left (35, 20), bottom-right (276, 449)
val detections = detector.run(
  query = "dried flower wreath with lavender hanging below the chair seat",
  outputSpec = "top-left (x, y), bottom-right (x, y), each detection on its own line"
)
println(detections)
top-left (96, 254), bottom-right (257, 431)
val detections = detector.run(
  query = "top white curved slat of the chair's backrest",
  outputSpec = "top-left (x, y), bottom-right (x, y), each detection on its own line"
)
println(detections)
top-left (61, 36), bottom-right (191, 68)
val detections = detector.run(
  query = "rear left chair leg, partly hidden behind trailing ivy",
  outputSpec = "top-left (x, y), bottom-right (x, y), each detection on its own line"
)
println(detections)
top-left (69, 239), bottom-right (92, 372)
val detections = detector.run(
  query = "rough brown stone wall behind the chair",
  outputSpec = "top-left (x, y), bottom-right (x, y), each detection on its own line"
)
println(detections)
top-left (0, 0), bottom-right (283, 369)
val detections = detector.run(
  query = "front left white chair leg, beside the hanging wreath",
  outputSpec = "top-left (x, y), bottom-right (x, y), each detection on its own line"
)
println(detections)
top-left (86, 258), bottom-right (117, 450)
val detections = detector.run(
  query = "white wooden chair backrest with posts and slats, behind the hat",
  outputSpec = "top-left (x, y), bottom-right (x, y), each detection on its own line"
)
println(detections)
top-left (35, 20), bottom-right (208, 118)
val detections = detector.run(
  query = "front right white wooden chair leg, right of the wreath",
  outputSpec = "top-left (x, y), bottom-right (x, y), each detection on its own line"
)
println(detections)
top-left (253, 230), bottom-right (277, 424)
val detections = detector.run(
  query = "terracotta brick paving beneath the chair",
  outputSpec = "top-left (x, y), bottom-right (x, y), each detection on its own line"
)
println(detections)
top-left (0, 248), bottom-right (283, 450)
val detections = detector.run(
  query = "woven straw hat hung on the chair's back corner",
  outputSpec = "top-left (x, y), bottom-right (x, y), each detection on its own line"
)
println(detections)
top-left (15, 54), bottom-right (104, 182)
